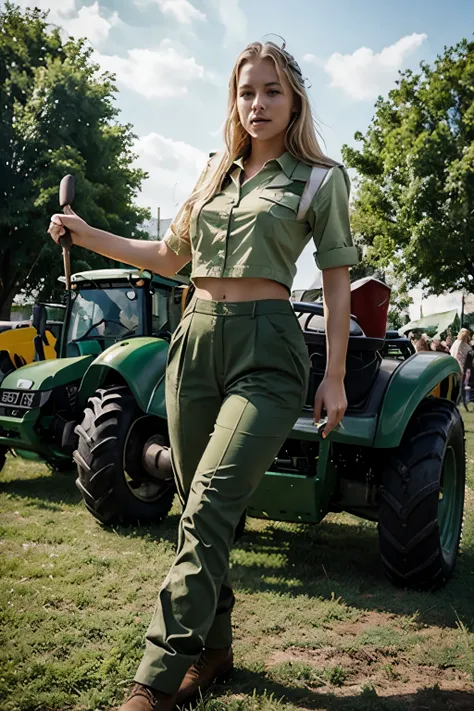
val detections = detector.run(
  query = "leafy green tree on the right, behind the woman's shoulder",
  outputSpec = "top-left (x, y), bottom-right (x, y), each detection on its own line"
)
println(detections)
top-left (343, 40), bottom-right (474, 293)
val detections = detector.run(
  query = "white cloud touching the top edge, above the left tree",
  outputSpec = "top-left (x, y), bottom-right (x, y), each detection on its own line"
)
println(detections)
top-left (15, 0), bottom-right (119, 45)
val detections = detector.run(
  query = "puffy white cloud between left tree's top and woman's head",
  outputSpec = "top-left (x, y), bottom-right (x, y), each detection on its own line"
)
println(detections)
top-left (94, 40), bottom-right (206, 99)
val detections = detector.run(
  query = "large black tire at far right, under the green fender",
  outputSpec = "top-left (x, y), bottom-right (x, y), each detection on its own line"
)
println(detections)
top-left (379, 398), bottom-right (466, 589)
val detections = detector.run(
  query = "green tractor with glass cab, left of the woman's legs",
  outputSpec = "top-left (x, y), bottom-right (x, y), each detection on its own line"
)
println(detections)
top-left (0, 268), bottom-right (187, 524)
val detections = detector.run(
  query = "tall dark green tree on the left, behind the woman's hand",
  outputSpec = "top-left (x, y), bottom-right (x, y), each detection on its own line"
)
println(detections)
top-left (0, 3), bottom-right (150, 318)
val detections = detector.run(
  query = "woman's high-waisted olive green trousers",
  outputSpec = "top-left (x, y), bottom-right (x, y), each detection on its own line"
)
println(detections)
top-left (135, 297), bottom-right (310, 694)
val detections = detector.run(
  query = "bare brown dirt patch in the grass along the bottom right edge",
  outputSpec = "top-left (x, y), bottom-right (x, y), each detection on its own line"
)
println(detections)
top-left (266, 647), bottom-right (474, 696)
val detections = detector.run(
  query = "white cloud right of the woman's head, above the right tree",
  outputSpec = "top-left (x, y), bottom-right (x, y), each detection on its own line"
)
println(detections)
top-left (305, 33), bottom-right (427, 101)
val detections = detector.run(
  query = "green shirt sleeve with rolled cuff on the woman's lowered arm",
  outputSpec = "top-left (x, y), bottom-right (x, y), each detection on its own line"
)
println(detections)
top-left (308, 166), bottom-right (359, 270)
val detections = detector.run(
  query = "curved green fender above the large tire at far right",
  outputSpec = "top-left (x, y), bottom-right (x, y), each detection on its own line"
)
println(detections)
top-left (374, 351), bottom-right (462, 448)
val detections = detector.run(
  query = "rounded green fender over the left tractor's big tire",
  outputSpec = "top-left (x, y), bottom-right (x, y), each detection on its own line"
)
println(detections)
top-left (78, 337), bottom-right (168, 418)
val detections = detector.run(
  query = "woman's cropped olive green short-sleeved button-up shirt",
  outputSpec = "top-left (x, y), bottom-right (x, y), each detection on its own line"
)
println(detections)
top-left (165, 152), bottom-right (358, 292)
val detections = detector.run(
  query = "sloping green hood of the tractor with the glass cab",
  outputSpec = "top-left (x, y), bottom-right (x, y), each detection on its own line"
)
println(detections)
top-left (1, 355), bottom-right (95, 392)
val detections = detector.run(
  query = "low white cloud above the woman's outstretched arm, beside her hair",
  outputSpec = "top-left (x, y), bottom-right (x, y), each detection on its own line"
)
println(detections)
top-left (134, 133), bottom-right (208, 219)
